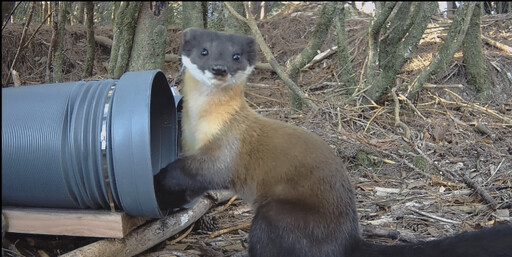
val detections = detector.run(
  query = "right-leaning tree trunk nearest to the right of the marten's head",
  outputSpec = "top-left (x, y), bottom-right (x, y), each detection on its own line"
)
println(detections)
top-left (286, 2), bottom-right (337, 110)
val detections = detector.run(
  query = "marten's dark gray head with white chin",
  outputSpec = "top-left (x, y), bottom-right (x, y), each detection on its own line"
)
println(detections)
top-left (181, 28), bottom-right (256, 87)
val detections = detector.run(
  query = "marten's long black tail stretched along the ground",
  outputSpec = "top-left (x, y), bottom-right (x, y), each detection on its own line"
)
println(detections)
top-left (347, 225), bottom-right (512, 257)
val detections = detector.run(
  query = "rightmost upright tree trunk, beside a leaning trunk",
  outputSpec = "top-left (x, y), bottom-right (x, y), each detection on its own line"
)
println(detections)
top-left (462, 2), bottom-right (491, 98)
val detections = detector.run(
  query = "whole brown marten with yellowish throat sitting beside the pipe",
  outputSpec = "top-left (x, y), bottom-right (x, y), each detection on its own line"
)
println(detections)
top-left (155, 29), bottom-right (512, 257)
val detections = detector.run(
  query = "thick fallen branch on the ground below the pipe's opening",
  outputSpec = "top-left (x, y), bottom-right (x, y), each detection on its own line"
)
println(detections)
top-left (61, 191), bottom-right (233, 257)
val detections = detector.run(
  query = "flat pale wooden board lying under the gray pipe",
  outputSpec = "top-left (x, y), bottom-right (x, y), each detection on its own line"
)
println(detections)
top-left (2, 206), bottom-right (148, 238)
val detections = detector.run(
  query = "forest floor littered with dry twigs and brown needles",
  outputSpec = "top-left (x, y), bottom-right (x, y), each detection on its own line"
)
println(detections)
top-left (2, 4), bottom-right (512, 256)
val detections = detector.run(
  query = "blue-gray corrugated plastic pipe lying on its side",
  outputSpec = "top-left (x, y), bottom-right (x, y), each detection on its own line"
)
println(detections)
top-left (2, 70), bottom-right (179, 217)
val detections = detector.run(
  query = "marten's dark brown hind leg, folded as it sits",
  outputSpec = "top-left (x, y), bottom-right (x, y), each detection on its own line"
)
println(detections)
top-left (249, 200), bottom-right (343, 257)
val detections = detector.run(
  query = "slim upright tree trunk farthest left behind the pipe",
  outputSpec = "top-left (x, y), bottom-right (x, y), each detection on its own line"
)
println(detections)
top-left (53, 2), bottom-right (70, 82)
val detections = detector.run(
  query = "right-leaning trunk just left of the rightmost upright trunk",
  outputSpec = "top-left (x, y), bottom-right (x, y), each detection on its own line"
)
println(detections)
top-left (408, 2), bottom-right (476, 98)
